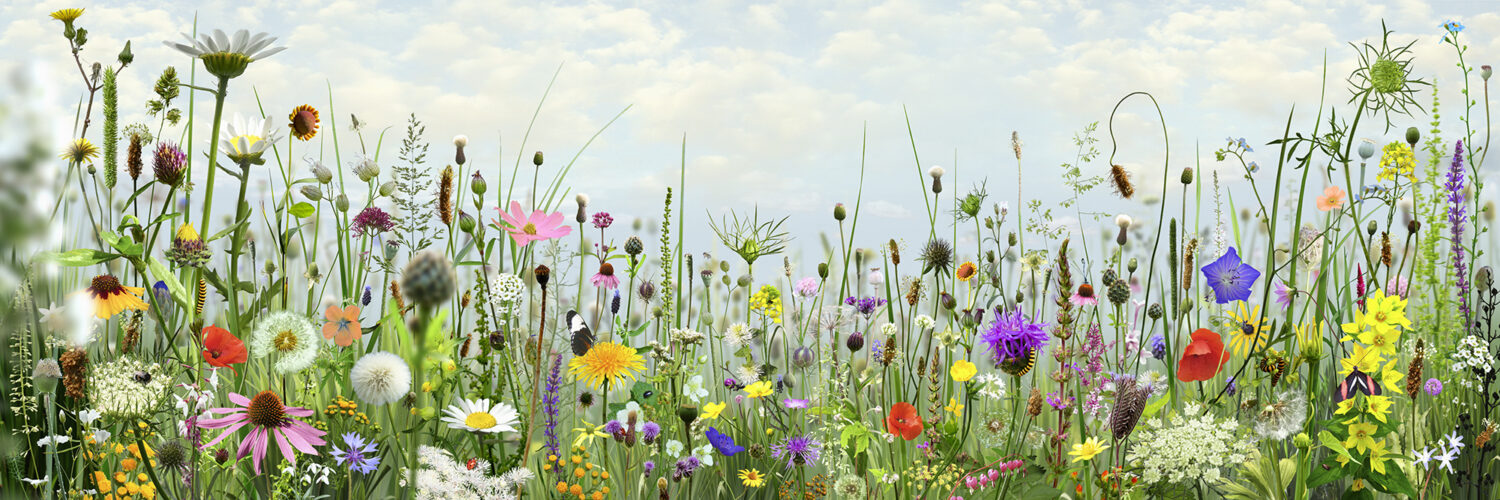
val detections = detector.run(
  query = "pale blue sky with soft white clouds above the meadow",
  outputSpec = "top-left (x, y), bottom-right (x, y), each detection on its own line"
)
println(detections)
top-left (0, 0), bottom-right (1500, 276)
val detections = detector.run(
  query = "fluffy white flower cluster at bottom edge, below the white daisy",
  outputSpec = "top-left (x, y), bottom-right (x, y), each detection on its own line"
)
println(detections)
top-left (417, 446), bottom-right (533, 500)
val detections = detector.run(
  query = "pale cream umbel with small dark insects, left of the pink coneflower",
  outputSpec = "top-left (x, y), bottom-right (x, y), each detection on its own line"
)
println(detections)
top-left (89, 357), bottom-right (171, 419)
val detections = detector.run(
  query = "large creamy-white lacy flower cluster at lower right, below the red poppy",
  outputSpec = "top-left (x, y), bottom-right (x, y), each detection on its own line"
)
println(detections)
top-left (1128, 402), bottom-right (1256, 483)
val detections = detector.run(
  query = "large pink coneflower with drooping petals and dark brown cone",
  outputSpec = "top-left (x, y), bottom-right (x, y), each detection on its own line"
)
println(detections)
top-left (198, 390), bottom-right (327, 474)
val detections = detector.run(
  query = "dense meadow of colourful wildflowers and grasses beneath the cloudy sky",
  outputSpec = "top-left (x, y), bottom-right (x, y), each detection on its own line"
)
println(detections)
top-left (0, 9), bottom-right (1500, 500)
